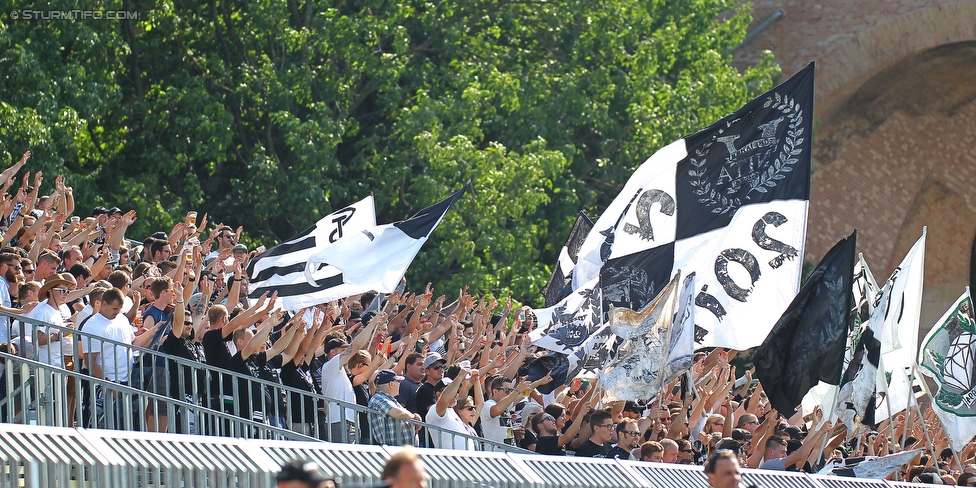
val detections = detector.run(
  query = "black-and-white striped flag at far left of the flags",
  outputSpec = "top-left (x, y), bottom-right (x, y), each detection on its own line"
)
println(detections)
top-left (247, 195), bottom-right (376, 311)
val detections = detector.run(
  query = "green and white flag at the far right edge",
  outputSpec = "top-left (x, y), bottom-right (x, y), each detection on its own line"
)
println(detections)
top-left (918, 287), bottom-right (976, 452)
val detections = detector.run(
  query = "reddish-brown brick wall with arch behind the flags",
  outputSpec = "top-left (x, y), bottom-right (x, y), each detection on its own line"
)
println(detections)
top-left (735, 0), bottom-right (976, 337)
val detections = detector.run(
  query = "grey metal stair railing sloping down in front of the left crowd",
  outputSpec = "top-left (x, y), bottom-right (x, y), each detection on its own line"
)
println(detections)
top-left (0, 312), bottom-right (529, 453)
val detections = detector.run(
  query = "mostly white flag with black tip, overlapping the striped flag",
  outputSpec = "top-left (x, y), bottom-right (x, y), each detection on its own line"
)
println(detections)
top-left (305, 185), bottom-right (467, 305)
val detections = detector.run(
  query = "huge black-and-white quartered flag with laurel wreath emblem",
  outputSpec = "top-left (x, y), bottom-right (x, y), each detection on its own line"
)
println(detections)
top-left (573, 64), bottom-right (813, 350)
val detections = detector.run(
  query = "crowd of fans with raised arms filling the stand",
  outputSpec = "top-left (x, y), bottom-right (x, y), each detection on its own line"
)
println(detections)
top-left (0, 153), bottom-right (976, 486)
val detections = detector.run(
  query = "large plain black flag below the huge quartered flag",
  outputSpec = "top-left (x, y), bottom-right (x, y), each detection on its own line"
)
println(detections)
top-left (753, 230), bottom-right (857, 417)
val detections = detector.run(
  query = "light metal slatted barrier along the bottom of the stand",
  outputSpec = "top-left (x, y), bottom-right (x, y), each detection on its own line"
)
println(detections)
top-left (0, 424), bottom-right (926, 488)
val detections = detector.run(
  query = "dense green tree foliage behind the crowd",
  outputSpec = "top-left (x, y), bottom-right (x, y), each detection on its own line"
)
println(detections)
top-left (0, 0), bottom-right (778, 303)
